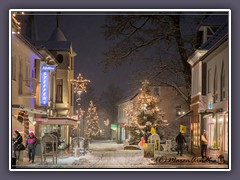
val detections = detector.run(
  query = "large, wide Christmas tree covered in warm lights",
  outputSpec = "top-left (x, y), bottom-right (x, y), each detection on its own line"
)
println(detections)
top-left (125, 80), bottom-right (168, 144)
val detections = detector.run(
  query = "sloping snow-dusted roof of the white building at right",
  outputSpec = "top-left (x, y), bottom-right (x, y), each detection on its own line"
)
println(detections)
top-left (199, 22), bottom-right (228, 50)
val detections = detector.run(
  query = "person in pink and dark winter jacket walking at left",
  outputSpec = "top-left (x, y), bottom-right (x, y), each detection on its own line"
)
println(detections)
top-left (26, 132), bottom-right (37, 163)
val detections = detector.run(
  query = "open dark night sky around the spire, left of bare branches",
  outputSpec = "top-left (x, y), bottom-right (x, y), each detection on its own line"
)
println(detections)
top-left (32, 14), bottom-right (147, 95)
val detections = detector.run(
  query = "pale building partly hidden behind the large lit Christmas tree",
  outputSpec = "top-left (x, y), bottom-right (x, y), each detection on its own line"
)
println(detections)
top-left (118, 85), bottom-right (190, 142)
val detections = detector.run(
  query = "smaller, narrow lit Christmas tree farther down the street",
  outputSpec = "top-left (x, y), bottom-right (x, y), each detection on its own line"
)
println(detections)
top-left (85, 101), bottom-right (99, 138)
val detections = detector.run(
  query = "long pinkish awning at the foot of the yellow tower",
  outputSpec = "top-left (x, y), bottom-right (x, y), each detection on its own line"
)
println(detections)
top-left (34, 117), bottom-right (77, 126)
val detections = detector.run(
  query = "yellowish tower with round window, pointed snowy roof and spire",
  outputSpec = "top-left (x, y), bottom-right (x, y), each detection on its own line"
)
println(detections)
top-left (45, 15), bottom-right (76, 117)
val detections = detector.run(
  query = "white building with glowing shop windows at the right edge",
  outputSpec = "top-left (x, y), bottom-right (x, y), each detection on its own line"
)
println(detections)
top-left (188, 16), bottom-right (229, 159)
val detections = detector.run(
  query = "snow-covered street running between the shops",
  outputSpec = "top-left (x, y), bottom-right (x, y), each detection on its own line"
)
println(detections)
top-left (17, 141), bottom-right (228, 169)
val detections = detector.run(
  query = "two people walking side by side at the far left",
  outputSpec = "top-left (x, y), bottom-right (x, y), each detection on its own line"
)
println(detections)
top-left (12, 130), bottom-right (37, 163)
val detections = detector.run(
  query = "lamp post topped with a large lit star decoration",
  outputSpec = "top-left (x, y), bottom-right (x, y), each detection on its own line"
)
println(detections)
top-left (71, 73), bottom-right (90, 148)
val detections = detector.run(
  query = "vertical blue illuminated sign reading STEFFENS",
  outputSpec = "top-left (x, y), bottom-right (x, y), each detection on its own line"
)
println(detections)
top-left (40, 66), bottom-right (49, 106)
